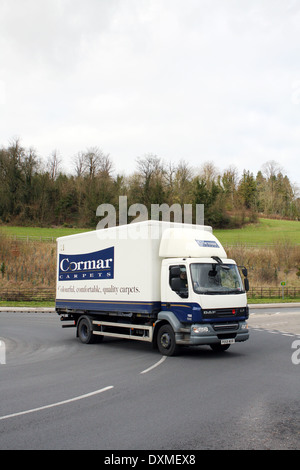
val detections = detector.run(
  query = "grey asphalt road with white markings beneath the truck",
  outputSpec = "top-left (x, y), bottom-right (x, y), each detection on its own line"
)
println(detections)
top-left (0, 307), bottom-right (300, 453)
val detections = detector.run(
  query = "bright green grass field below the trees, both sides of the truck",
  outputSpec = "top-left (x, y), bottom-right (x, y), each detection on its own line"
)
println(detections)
top-left (0, 219), bottom-right (300, 245)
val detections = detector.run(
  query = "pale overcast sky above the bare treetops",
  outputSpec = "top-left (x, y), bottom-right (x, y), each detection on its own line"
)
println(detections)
top-left (0, 0), bottom-right (300, 186)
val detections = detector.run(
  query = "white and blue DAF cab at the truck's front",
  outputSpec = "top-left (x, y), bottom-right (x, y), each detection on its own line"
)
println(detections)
top-left (158, 226), bottom-right (249, 351)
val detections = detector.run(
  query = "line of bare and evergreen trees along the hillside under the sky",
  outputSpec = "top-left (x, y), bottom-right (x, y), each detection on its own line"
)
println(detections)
top-left (0, 139), bottom-right (300, 228)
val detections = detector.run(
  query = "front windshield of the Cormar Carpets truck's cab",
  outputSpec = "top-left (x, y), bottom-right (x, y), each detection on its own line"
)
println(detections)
top-left (191, 263), bottom-right (245, 295)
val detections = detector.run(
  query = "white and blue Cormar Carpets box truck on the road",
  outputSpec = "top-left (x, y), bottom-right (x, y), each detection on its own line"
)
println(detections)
top-left (56, 221), bottom-right (249, 356)
